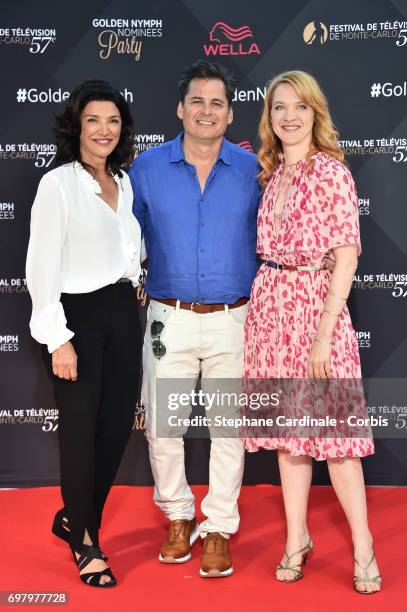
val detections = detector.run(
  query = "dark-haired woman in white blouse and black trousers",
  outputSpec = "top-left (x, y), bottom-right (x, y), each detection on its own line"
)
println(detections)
top-left (27, 81), bottom-right (142, 587)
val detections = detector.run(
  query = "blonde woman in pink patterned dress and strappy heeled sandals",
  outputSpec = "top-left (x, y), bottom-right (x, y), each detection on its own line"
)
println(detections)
top-left (244, 71), bottom-right (381, 593)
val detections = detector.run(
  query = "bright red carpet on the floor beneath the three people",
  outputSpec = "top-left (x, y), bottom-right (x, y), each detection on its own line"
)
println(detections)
top-left (0, 485), bottom-right (407, 612)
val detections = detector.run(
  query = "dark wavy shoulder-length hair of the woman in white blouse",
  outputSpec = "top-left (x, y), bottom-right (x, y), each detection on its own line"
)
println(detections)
top-left (53, 79), bottom-right (134, 176)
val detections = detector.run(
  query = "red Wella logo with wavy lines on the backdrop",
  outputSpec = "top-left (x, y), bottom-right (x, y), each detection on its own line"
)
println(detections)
top-left (203, 21), bottom-right (260, 55)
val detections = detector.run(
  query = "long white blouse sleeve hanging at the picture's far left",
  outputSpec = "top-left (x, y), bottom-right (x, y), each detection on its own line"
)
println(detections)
top-left (26, 174), bottom-right (74, 353)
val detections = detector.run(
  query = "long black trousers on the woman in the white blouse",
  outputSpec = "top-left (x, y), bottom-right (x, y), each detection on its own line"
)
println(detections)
top-left (43, 283), bottom-right (142, 550)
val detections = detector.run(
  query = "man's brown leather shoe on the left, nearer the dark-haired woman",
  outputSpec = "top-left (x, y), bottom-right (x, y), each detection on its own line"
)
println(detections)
top-left (158, 518), bottom-right (199, 563)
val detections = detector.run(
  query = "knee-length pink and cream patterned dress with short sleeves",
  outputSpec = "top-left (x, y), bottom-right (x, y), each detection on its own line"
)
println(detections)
top-left (244, 152), bottom-right (374, 460)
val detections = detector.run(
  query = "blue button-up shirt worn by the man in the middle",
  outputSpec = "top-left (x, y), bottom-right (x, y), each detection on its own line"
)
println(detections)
top-left (129, 134), bottom-right (260, 304)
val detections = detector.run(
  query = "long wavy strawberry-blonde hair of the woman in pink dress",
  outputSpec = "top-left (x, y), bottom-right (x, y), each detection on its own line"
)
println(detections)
top-left (258, 70), bottom-right (344, 188)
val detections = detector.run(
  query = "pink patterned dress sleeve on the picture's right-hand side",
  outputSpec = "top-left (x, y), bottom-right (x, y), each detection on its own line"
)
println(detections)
top-left (316, 162), bottom-right (361, 255)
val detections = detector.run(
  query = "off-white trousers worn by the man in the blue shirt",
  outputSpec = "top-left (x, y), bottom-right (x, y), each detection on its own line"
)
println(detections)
top-left (142, 300), bottom-right (248, 537)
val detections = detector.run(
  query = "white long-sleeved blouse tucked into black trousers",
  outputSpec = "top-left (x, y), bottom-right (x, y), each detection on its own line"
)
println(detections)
top-left (26, 162), bottom-right (141, 353)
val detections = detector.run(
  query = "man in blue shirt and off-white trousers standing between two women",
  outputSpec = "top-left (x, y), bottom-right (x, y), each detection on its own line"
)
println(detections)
top-left (130, 61), bottom-right (260, 577)
